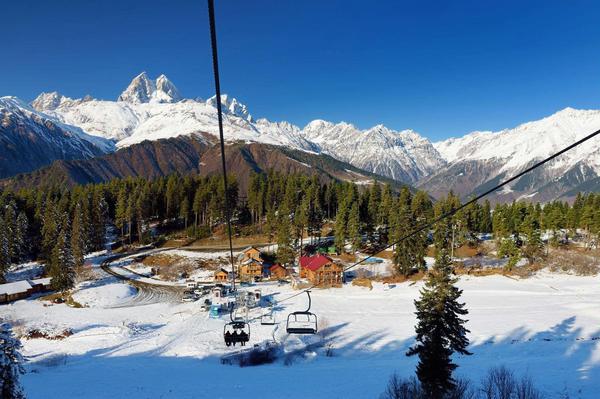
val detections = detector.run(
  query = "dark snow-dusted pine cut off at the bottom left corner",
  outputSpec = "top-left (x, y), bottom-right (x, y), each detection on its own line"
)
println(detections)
top-left (0, 323), bottom-right (25, 399)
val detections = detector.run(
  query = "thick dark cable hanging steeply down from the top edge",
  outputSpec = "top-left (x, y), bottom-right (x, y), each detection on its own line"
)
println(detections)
top-left (208, 0), bottom-right (236, 291)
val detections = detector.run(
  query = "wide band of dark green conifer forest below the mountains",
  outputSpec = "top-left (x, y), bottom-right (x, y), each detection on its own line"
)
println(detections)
top-left (0, 172), bottom-right (600, 288)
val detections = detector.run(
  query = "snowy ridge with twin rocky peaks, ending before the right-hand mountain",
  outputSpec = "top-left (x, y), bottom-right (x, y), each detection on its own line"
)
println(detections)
top-left (32, 73), bottom-right (445, 183)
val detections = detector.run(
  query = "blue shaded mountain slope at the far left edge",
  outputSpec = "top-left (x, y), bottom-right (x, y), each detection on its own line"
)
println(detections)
top-left (0, 96), bottom-right (115, 177)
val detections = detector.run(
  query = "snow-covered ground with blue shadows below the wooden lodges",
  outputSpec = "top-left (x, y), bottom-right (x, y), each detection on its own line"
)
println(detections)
top-left (0, 253), bottom-right (600, 399)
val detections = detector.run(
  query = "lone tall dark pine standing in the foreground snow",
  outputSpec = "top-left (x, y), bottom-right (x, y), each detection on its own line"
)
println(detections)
top-left (407, 247), bottom-right (471, 399)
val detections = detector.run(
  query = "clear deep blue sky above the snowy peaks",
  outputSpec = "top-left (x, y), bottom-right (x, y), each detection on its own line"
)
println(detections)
top-left (0, 0), bottom-right (600, 140)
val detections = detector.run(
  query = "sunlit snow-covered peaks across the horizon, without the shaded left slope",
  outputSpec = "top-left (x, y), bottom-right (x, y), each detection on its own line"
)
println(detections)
top-left (23, 73), bottom-right (600, 200)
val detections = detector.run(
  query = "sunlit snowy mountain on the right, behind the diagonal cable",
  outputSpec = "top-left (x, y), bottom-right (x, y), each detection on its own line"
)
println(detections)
top-left (420, 108), bottom-right (600, 201)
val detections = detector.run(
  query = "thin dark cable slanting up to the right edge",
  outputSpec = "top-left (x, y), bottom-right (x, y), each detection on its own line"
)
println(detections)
top-left (277, 130), bottom-right (600, 303)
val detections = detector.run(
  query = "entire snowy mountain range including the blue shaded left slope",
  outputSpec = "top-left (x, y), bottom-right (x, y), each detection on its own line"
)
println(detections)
top-left (0, 73), bottom-right (600, 201)
